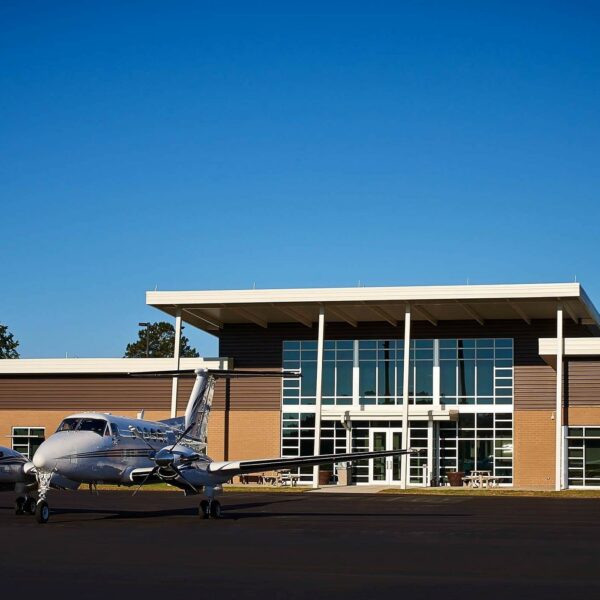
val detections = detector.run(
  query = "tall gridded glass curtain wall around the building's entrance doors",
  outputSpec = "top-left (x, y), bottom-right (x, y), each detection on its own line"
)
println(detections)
top-left (282, 339), bottom-right (512, 484)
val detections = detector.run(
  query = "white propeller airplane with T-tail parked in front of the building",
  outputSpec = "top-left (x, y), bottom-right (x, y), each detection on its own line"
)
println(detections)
top-left (25, 369), bottom-right (413, 523)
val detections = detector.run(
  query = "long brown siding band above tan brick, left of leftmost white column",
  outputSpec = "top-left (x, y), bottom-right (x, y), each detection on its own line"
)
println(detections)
top-left (0, 377), bottom-right (171, 412)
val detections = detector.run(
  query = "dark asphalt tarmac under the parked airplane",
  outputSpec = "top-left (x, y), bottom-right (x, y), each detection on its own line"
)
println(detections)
top-left (0, 491), bottom-right (600, 600)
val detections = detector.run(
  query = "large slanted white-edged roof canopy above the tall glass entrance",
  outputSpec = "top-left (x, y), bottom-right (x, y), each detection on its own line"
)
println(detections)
top-left (146, 283), bottom-right (600, 332)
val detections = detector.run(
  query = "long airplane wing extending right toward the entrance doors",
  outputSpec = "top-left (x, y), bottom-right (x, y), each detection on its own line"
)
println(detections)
top-left (208, 450), bottom-right (418, 477)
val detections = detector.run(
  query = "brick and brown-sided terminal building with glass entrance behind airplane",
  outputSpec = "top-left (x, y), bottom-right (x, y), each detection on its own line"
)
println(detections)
top-left (0, 283), bottom-right (600, 490)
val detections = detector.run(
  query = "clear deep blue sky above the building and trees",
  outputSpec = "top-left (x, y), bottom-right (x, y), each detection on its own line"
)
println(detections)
top-left (0, 0), bottom-right (600, 357)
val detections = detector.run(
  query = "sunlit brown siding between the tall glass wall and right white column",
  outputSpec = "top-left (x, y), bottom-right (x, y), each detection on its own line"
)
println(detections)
top-left (514, 365), bottom-right (556, 411)
